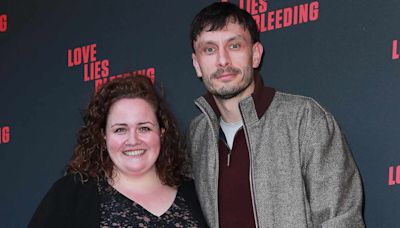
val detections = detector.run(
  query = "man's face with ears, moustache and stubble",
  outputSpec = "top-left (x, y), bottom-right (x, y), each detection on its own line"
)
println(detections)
top-left (192, 23), bottom-right (263, 99)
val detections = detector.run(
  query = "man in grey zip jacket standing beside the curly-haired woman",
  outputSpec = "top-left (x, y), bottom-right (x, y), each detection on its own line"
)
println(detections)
top-left (189, 3), bottom-right (364, 228)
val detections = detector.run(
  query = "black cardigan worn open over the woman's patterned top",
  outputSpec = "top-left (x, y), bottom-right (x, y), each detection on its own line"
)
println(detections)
top-left (28, 175), bottom-right (206, 228)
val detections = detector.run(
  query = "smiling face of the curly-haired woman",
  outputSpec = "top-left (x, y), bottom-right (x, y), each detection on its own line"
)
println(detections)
top-left (105, 98), bottom-right (161, 177)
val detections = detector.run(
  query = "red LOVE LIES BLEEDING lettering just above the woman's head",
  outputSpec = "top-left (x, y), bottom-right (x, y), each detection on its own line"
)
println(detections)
top-left (67, 43), bottom-right (155, 91)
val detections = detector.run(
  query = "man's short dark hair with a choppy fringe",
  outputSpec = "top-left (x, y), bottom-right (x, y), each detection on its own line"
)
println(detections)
top-left (190, 2), bottom-right (260, 52)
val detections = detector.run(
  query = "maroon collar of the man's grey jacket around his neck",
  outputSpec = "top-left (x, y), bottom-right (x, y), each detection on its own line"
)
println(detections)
top-left (196, 72), bottom-right (276, 119)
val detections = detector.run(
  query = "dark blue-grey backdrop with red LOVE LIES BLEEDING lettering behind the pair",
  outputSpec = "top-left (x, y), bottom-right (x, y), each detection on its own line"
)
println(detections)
top-left (0, 0), bottom-right (400, 227)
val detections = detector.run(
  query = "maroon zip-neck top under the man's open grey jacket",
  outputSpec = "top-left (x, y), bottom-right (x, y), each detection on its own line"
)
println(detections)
top-left (218, 128), bottom-right (255, 228)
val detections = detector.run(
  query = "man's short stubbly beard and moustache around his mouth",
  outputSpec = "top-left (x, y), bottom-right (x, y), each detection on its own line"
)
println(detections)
top-left (206, 67), bottom-right (253, 100)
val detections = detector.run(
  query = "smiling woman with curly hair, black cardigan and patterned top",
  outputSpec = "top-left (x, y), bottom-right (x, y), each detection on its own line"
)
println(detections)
top-left (29, 76), bottom-right (206, 227)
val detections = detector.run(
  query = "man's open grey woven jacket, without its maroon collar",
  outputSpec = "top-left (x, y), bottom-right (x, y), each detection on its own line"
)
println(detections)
top-left (189, 87), bottom-right (364, 228)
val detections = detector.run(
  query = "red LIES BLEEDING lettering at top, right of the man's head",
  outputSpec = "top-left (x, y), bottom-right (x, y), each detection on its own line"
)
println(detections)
top-left (221, 0), bottom-right (319, 32)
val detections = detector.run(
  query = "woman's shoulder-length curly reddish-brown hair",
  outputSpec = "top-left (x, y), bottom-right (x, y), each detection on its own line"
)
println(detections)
top-left (66, 75), bottom-right (189, 186)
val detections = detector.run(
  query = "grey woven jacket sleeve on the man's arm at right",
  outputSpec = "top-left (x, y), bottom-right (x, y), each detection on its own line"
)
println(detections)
top-left (303, 113), bottom-right (364, 228)
